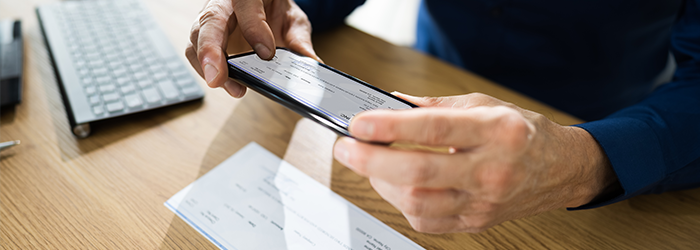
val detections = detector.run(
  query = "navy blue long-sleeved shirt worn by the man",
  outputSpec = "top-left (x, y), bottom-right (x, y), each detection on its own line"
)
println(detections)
top-left (297, 0), bottom-right (700, 208)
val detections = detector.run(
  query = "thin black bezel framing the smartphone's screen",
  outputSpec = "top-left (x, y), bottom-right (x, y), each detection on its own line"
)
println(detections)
top-left (226, 47), bottom-right (418, 137)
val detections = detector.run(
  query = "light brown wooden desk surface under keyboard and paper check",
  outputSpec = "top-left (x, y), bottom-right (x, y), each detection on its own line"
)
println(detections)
top-left (0, 0), bottom-right (700, 249)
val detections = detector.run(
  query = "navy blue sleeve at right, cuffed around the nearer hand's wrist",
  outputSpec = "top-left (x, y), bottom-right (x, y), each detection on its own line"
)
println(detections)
top-left (575, 0), bottom-right (700, 209)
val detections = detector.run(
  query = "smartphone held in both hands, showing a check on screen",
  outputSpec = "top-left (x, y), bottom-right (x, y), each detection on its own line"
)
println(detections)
top-left (227, 47), bottom-right (418, 137)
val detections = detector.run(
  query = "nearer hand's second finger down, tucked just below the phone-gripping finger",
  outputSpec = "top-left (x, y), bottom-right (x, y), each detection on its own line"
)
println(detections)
top-left (333, 138), bottom-right (474, 188)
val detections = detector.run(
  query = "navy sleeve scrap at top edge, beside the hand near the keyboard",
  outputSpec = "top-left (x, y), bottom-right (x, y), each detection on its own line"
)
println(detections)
top-left (295, 0), bottom-right (365, 31)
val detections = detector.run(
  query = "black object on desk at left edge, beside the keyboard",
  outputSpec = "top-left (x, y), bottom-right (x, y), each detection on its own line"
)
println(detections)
top-left (0, 20), bottom-right (24, 107)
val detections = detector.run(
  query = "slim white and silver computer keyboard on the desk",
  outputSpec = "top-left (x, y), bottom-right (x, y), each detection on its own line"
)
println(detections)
top-left (37, 0), bottom-right (204, 138)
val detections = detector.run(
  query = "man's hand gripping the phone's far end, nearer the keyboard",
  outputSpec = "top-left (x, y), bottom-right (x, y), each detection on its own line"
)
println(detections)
top-left (185, 0), bottom-right (319, 98)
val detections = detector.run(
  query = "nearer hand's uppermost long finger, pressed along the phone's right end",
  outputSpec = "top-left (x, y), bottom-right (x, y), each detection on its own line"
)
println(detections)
top-left (349, 107), bottom-right (517, 146)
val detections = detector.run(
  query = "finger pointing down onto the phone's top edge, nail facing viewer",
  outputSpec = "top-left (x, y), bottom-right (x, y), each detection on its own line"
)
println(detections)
top-left (233, 0), bottom-right (275, 60)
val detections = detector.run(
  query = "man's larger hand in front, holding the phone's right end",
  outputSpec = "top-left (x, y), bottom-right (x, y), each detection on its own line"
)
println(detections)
top-left (334, 94), bottom-right (617, 233)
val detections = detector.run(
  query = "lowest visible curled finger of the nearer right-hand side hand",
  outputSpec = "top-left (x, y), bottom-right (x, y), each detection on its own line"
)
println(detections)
top-left (369, 177), bottom-right (469, 218)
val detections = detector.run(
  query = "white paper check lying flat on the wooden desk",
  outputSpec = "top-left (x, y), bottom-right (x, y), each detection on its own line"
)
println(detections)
top-left (165, 142), bottom-right (424, 250)
